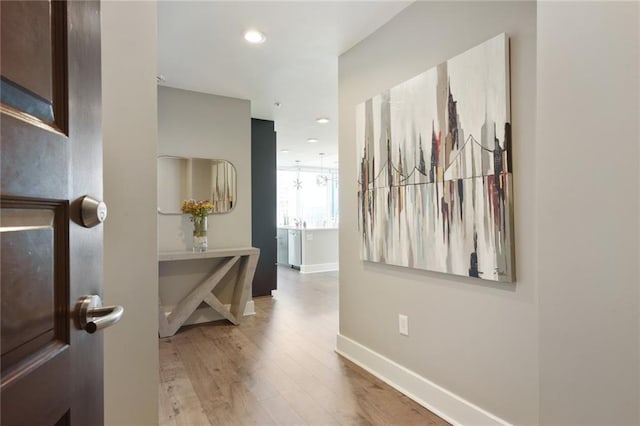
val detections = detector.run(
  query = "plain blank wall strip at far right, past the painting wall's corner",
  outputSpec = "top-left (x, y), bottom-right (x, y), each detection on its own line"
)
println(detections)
top-left (536, 2), bottom-right (640, 425)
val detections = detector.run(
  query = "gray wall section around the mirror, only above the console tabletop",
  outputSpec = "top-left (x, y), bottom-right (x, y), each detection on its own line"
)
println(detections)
top-left (158, 87), bottom-right (251, 250)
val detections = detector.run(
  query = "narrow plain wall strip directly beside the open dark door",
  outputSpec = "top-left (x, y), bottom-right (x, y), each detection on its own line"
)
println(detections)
top-left (102, 2), bottom-right (158, 426)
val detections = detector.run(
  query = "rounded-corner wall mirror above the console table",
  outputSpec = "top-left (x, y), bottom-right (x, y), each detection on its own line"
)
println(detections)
top-left (158, 155), bottom-right (237, 214)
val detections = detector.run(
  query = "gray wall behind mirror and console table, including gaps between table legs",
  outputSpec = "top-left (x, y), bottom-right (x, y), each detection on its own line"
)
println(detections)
top-left (157, 86), bottom-right (251, 324)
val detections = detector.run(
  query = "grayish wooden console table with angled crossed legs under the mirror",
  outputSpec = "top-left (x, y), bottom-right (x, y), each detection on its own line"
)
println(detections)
top-left (158, 247), bottom-right (260, 337)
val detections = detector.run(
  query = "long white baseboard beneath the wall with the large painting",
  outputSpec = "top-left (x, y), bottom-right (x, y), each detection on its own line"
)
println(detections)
top-left (336, 334), bottom-right (509, 426)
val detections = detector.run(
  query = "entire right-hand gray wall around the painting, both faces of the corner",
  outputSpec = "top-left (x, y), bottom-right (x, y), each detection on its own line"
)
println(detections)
top-left (339, 2), bottom-right (640, 424)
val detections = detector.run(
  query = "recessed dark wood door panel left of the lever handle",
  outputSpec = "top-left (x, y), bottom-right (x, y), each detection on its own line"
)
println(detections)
top-left (0, 198), bottom-right (69, 375)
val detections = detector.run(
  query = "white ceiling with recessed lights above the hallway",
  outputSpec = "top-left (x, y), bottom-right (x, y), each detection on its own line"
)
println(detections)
top-left (158, 1), bottom-right (411, 168)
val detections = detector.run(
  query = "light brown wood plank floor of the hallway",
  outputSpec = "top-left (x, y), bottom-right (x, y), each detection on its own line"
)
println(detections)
top-left (159, 267), bottom-right (448, 426)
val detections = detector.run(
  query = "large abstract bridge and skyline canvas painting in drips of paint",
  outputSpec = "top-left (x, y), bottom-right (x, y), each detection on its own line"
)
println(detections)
top-left (356, 34), bottom-right (515, 282)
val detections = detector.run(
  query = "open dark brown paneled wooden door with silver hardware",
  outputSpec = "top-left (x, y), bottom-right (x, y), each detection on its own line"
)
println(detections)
top-left (0, 0), bottom-right (103, 425)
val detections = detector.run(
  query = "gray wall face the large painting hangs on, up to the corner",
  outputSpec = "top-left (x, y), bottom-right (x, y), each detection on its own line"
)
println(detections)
top-left (339, 2), bottom-right (538, 424)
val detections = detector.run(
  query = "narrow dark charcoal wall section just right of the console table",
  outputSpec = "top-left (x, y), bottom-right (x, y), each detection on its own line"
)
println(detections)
top-left (251, 118), bottom-right (278, 296)
